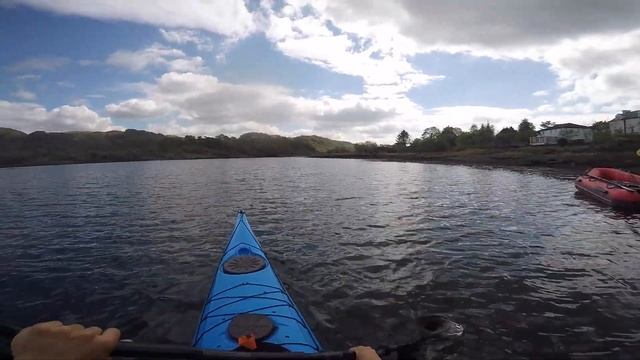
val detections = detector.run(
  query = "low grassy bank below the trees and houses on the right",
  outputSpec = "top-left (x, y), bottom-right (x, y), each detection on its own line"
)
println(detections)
top-left (321, 146), bottom-right (640, 171)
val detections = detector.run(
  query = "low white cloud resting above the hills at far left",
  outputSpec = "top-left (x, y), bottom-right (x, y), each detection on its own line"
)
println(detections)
top-left (0, 100), bottom-right (120, 132)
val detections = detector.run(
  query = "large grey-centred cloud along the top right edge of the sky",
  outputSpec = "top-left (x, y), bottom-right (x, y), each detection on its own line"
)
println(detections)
top-left (322, 0), bottom-right (640, 51)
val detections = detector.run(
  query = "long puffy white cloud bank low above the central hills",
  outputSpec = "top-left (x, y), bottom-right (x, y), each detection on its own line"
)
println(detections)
top-left (100, 72), bottom-right (616, 143)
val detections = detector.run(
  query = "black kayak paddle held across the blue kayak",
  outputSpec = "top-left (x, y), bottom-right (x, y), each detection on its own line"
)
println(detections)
top-left (0, 316), bottom-right (463, 360)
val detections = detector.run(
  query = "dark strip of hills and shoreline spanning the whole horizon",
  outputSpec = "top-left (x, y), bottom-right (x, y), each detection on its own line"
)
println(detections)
top-left (0, 127), bottom-right (640, 172)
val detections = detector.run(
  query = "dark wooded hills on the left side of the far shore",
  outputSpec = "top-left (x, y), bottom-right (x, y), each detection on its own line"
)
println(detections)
top-left (0, 128), bottom-right (354, 166)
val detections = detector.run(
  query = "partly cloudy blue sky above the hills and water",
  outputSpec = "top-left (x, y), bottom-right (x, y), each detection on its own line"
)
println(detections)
top-left (0, 0), bottom-right (640, 143)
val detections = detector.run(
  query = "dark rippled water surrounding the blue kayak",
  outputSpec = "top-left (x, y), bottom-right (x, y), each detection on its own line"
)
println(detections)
top-left (0, 158), bottom-right (640, 359)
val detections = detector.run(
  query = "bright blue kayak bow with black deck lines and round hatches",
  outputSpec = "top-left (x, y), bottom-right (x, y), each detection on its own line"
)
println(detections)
top-left (193, 211), bottom-right (322, 353)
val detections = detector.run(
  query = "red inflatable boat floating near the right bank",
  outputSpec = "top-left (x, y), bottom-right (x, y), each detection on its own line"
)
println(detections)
top-left (576, 168), bottom-right (640, 210)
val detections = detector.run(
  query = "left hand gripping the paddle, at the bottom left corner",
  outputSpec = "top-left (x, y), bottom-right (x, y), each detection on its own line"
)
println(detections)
top-left (11, 321), bottom-right (120, 360)
